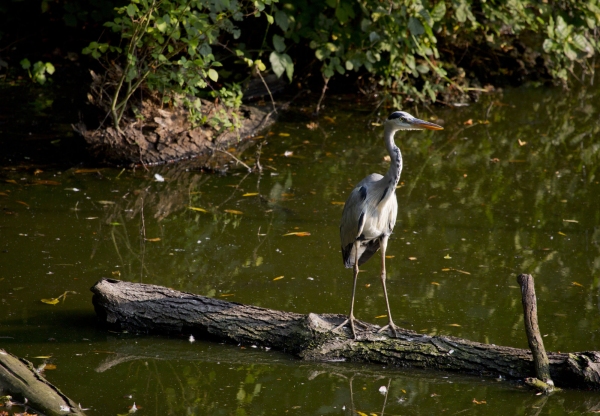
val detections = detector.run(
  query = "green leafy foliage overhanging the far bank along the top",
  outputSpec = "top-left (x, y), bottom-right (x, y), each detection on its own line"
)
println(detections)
top-left (84, 0), bottom-right (600, 126)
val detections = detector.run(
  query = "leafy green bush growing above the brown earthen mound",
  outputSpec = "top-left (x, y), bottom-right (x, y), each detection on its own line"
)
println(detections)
top-left (83, 0), bottom-right (271, 128)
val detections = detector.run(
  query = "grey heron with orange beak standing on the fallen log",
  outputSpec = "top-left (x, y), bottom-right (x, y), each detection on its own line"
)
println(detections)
top-left (334, 111), bottom-right (443, 339)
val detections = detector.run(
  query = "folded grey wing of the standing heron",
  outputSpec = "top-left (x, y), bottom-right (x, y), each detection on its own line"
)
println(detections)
top-left (340, 173), bottom-right (382, 267)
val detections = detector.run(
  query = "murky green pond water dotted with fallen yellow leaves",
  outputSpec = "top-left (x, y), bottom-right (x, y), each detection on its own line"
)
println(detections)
top-left (0, 83), bottom-right (600, 415)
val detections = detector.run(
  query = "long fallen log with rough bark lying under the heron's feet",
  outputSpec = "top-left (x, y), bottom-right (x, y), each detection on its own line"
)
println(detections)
top-left (91, 279), bottom-right (600, 390)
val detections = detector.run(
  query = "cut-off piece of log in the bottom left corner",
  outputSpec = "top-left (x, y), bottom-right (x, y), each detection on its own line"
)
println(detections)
top-left (0, 349), bottom-right (84, 416)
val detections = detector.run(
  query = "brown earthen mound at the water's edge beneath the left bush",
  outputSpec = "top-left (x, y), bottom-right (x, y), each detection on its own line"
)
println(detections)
top-left (73, 73), bottom-right (277, 167)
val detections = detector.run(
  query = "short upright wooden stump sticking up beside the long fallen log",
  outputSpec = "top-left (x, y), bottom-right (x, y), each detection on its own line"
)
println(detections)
top-left (517, 274), bottom-right (552, 383)
